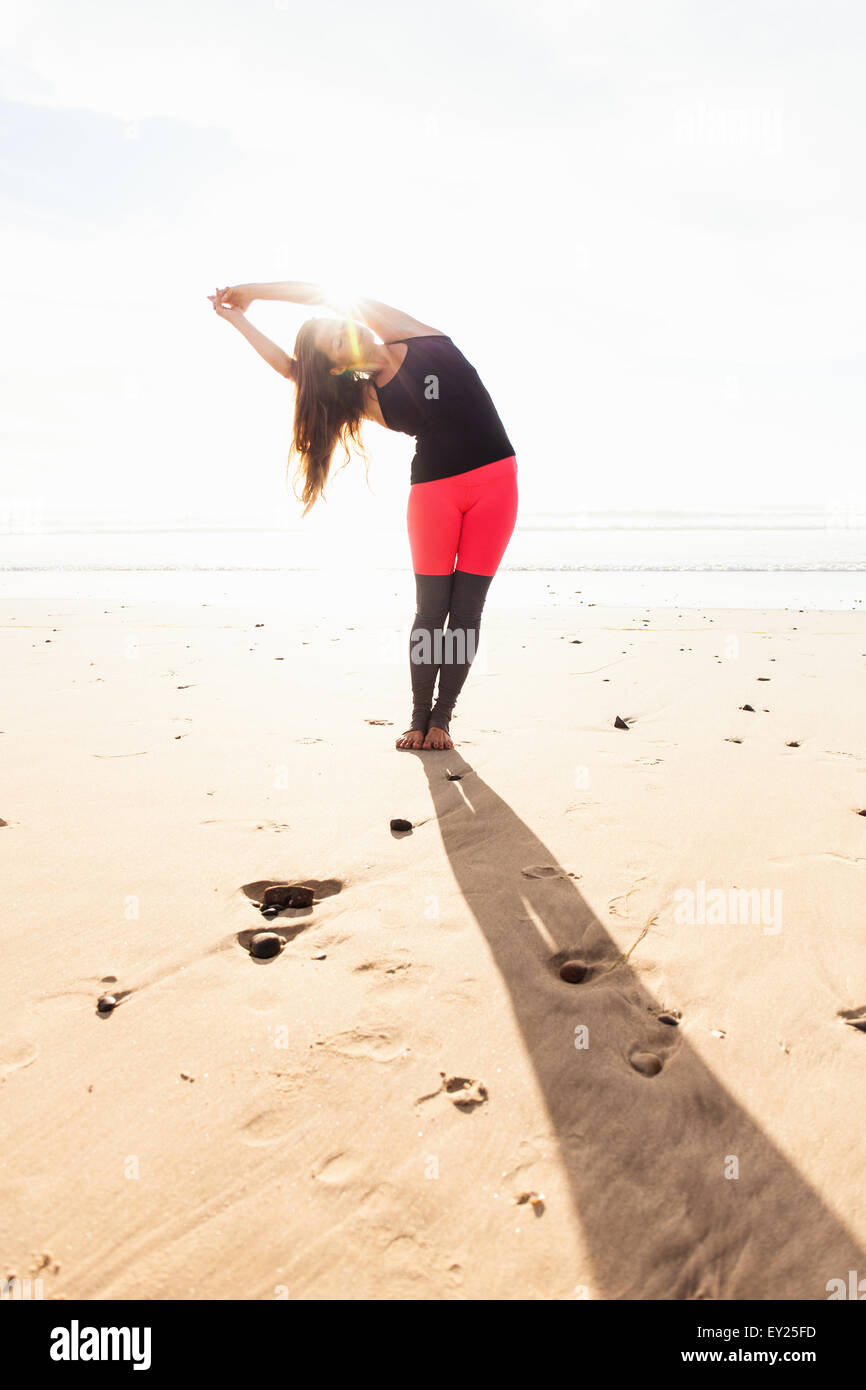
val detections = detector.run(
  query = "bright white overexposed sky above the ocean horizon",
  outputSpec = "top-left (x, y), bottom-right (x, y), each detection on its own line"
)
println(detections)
top-left (0, 0), bottom-right (866, 525)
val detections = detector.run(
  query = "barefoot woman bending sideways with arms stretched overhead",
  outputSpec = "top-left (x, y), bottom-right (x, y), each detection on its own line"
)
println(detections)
top-left (209, 282), bottom-right (517, 748)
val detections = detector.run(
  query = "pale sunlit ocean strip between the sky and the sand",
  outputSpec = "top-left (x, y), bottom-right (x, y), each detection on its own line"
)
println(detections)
top-left (0, 509), bottom-right (866, 610)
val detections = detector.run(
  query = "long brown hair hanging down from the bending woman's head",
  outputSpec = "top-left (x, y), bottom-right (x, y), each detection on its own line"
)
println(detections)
top-left (289, 318), bottom-right (367, 516)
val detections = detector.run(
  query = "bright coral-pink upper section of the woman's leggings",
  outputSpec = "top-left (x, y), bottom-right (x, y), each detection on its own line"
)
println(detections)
top-left (406, 455), bottom-right (517, 575)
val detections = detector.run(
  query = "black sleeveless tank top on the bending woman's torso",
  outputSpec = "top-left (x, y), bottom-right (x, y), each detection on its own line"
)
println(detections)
top-left (374, 334), bottom-right (514, 482)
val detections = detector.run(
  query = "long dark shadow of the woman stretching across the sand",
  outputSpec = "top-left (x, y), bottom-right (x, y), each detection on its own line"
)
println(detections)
top-left (414, 749), bottom-right (866, 1300)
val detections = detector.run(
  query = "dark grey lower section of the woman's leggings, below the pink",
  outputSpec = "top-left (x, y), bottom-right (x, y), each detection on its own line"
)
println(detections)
top-left (409, 570), bottom-right (493, 733)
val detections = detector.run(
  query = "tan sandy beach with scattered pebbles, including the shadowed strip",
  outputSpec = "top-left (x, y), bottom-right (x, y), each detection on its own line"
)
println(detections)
top-left (0, 586), bottom-right (866, 1300)
